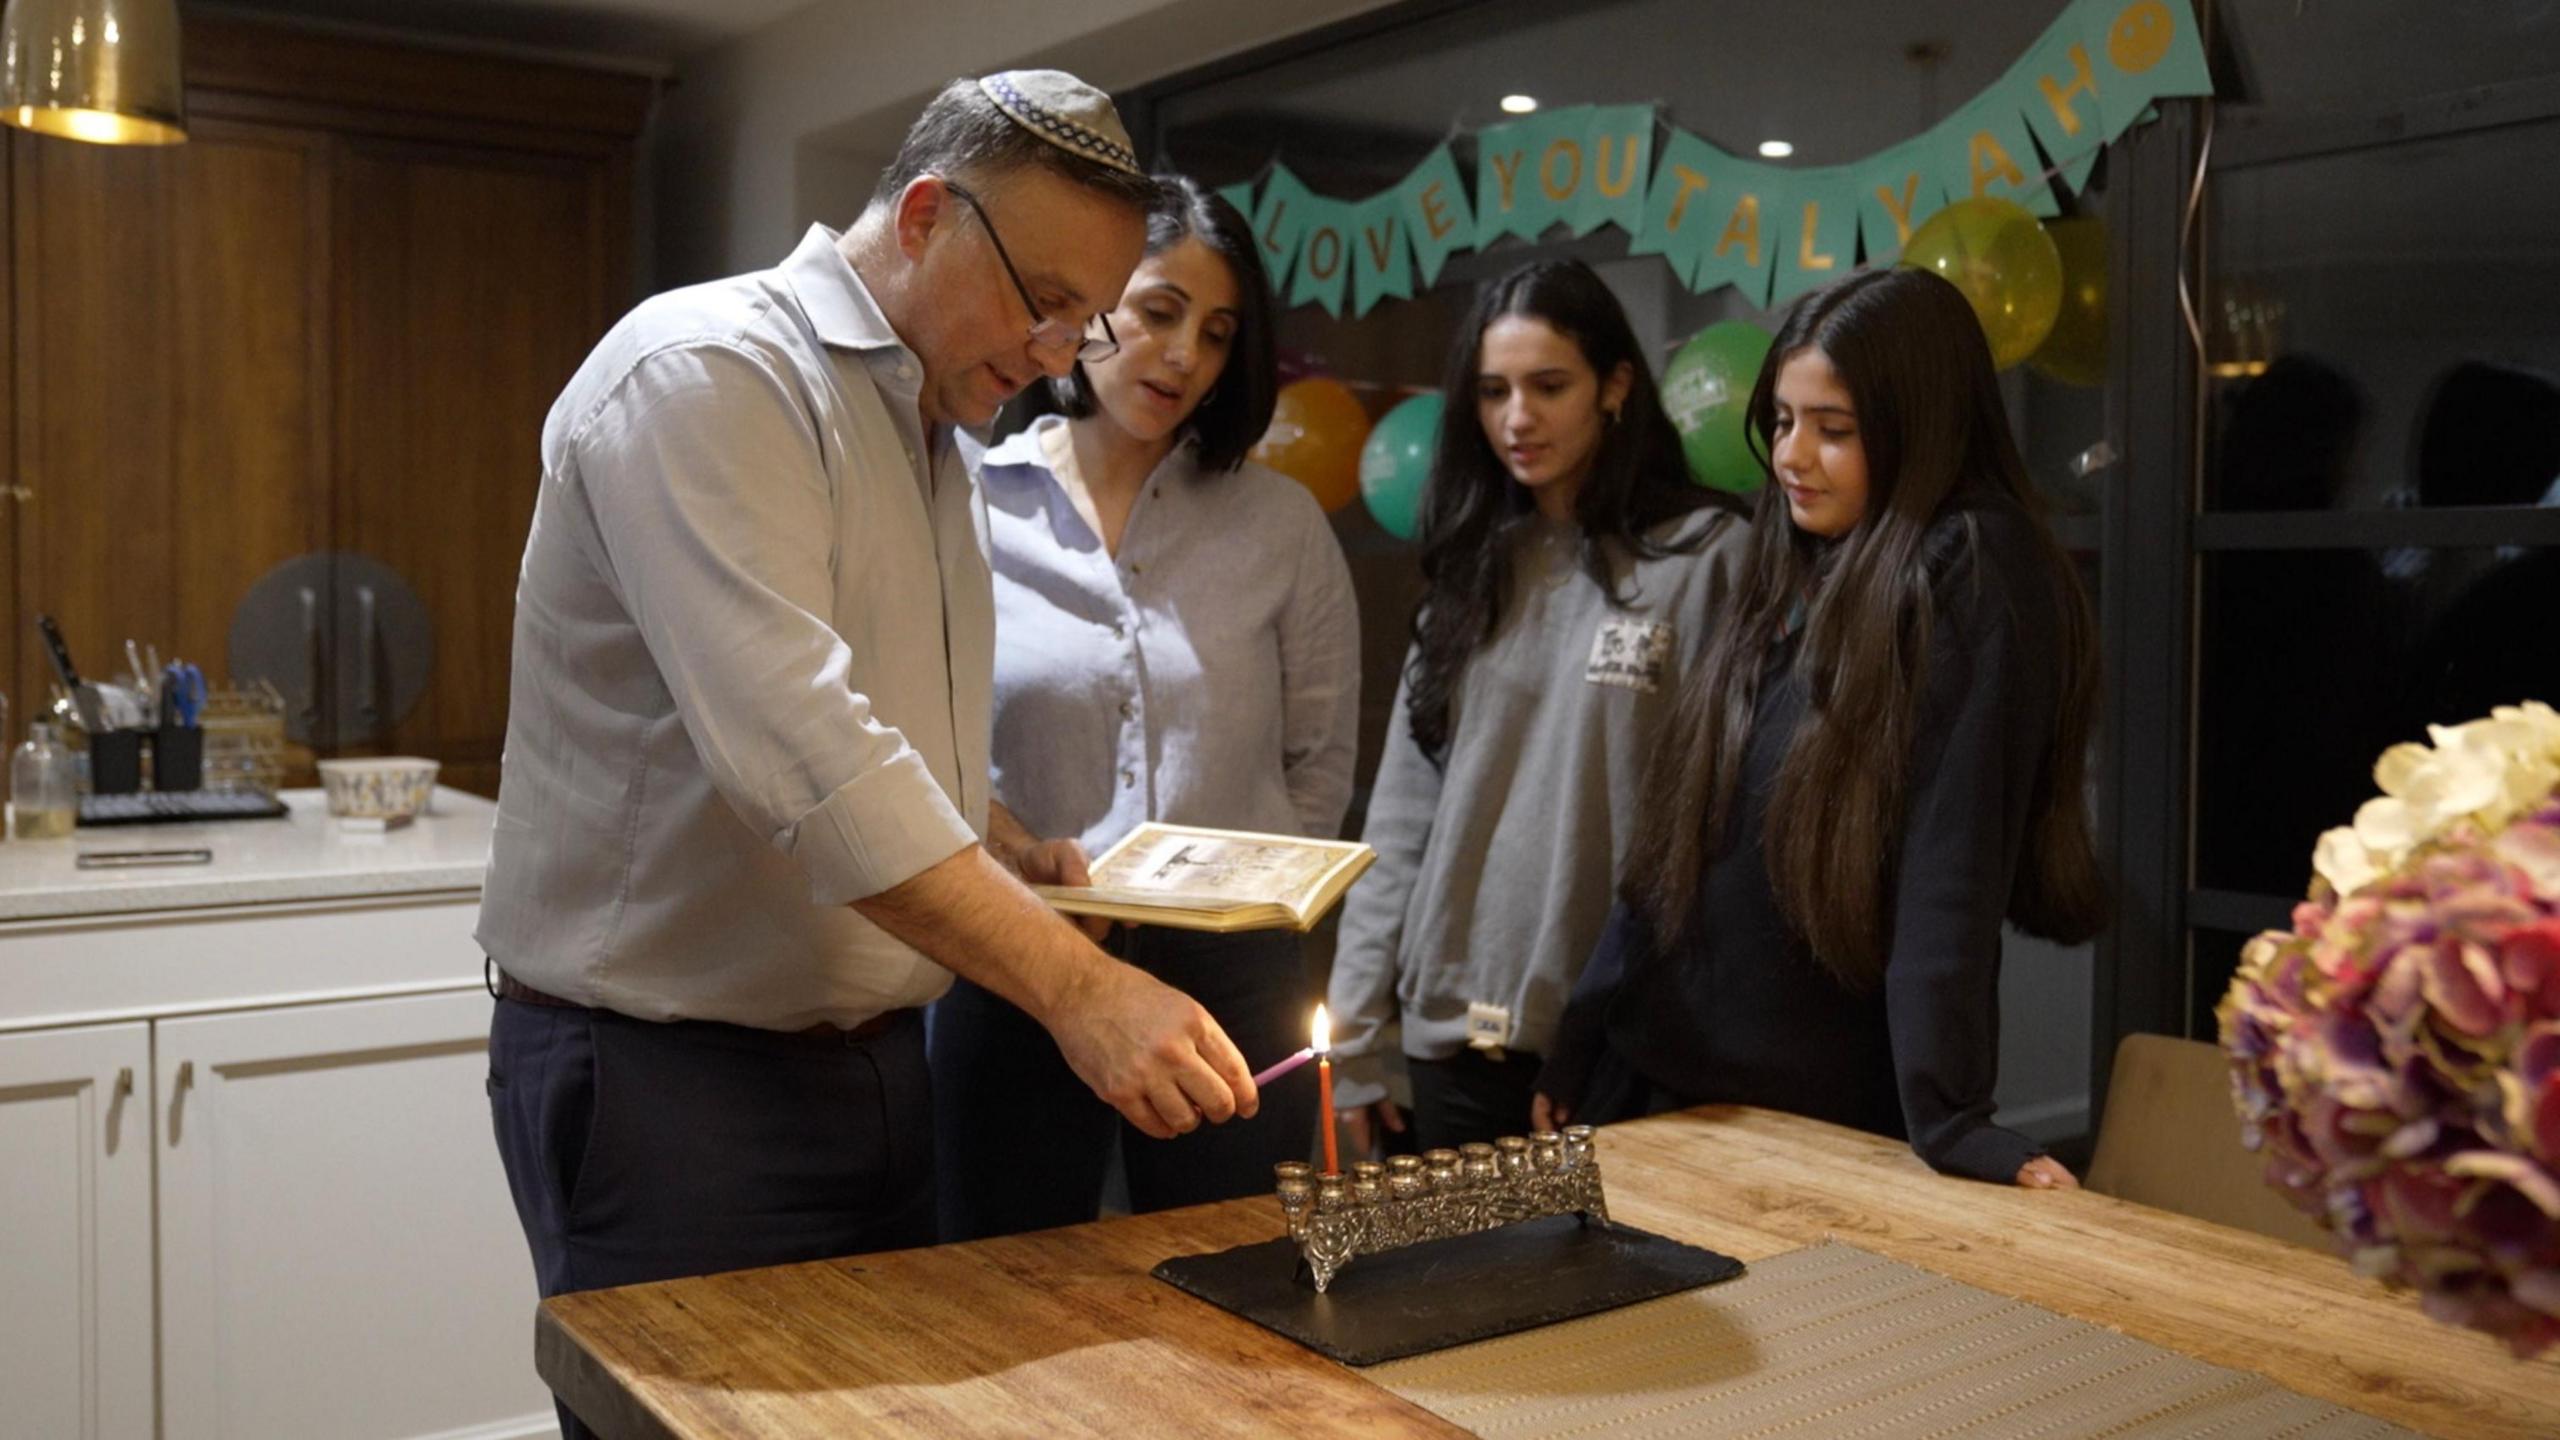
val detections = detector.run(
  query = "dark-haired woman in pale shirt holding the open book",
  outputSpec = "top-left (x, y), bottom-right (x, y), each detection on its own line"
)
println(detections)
top-left (932, 177), bottom-right (1359, 1240)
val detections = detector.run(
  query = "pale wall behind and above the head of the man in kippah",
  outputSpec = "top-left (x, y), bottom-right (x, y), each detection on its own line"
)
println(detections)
top-left (655, 0), bottom-right (1385, 290)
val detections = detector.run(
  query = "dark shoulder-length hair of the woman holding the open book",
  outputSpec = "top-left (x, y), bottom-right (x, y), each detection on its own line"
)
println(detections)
top-left (1044, 174), bottom-right (1280, 474)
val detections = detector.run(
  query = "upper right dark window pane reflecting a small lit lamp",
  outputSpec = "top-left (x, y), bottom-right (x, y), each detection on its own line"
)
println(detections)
top-left (2202, 120), bottom-right (2560, 510)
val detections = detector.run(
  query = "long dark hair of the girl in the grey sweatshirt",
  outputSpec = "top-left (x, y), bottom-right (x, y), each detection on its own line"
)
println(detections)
top-left (1405, 259), bottom-right (1723, 756)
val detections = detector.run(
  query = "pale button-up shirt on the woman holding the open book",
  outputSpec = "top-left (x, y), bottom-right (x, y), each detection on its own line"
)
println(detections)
top-left (978, 415), bottom-right (1359, 853)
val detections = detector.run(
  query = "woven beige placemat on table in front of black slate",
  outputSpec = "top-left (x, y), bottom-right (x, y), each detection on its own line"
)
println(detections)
top-left (1362, 1243), bottom-right (2412, 1440)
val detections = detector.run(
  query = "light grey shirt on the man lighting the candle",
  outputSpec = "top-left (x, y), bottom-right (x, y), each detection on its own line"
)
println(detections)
top-left (479, 228), bottom-right (996, 1030)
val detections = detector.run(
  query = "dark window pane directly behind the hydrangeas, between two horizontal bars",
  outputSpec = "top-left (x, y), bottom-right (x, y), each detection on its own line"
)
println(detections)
top-left (2196, 548), bottom-right (2560, 894)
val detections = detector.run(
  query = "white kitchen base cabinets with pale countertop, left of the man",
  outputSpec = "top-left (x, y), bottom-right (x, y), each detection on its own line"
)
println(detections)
top-left (0, 789), bottom-right (556, 1440)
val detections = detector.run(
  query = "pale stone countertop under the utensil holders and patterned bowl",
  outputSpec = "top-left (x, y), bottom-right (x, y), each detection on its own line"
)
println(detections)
top-left (0, 787), bottom-right (497, 922)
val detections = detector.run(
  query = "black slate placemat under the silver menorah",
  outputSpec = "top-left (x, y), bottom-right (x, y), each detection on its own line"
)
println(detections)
top-left (1155, 1215), bottom-right (1743, 1366)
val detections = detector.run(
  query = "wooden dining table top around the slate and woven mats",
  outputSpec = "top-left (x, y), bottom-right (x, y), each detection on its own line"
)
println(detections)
top-left (535, 1107), bottom-right (2560, 1440)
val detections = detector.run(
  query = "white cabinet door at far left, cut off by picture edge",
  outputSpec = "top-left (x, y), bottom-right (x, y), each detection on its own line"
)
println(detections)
top-left (0, 1022), bottom-right (151, 1440)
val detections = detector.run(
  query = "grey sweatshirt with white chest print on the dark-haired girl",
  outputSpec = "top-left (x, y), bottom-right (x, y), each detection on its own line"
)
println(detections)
top-left (1326, 510), bottom-right (1743, 1096)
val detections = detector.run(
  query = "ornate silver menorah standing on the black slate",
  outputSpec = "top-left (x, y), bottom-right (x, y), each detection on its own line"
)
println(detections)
top-left (1272, 1125), bottom-right (1608, 1294)
